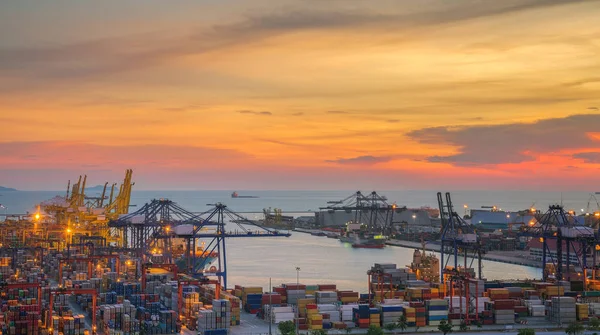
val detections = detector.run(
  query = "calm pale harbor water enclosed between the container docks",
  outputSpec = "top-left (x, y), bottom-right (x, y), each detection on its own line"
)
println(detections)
top-left (227, 233), bottom-right (542, 292)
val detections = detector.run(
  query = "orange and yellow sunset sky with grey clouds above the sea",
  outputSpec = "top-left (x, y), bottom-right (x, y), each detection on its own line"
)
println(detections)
top-left (0, 0), bottom-right (600, 191)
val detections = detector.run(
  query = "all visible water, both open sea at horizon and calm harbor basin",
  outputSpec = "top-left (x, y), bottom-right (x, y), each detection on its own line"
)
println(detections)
top-left (0, 191), bottom-right (596, 292)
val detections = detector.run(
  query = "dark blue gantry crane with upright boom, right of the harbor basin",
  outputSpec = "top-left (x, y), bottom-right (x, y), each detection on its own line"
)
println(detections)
top-left (437, 192), bottom-right (482, 282)
